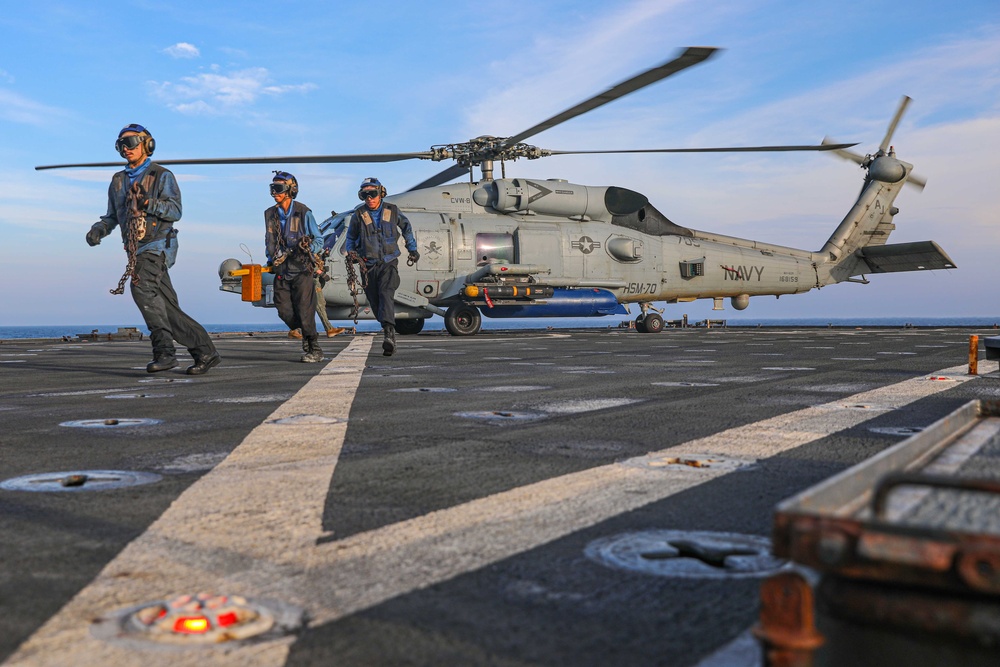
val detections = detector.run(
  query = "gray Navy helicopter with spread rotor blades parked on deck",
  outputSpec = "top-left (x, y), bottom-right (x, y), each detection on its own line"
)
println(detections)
top-left (36, 47), bottom-right (955, 336)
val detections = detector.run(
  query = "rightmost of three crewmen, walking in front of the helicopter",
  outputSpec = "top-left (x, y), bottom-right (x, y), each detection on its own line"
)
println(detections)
top-left (344, 178), bottom-right (420, 357)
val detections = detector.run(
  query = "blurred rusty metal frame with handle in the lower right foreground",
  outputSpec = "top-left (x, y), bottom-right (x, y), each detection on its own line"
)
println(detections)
top-left (772, 400), bottom-right (1000, 595)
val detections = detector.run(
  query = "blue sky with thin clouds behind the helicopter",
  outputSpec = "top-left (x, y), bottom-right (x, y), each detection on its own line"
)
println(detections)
top-left (0, 0), bottom-right (1000, 326)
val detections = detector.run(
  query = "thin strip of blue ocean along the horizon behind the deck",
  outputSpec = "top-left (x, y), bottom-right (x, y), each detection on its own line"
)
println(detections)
top-left (0, 316), bottom-right (1000, 340)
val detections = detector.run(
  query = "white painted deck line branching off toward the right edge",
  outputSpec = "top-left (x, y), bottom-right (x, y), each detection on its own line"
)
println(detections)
top-left (300, 366), bottom-right (976, 623)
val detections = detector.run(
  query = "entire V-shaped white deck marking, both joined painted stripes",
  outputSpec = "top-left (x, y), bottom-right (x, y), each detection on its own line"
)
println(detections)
top-left (9, 366), bottom-right (965, 667)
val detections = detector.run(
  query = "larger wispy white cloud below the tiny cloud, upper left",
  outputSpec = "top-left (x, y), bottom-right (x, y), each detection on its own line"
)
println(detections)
top-left (151, 66), bottom-right (316, 115)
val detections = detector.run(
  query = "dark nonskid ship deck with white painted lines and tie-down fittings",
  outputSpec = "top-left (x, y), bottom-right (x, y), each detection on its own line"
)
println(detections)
top-left (0, 328), bottom-right (1000, 665)
